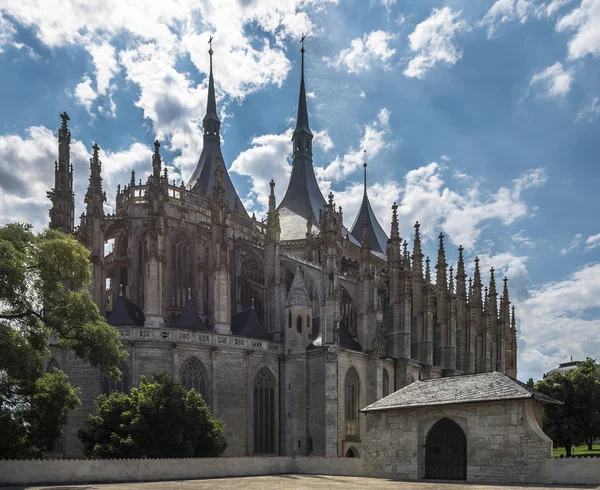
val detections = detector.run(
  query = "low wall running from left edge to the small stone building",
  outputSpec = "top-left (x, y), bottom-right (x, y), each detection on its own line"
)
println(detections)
top-left (0, 457), bottom-right (362, 486)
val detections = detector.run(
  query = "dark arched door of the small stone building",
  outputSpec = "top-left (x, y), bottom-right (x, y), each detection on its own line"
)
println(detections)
top-left (425, 419), bottom-right (467, 480)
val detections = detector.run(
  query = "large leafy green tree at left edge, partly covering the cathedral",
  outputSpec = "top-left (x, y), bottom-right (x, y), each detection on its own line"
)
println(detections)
top-left (0, 224), bottom-right (126, 458)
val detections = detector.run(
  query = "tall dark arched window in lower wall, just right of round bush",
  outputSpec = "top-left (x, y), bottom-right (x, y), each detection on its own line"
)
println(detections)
top-left (254, 368), bottom-right (275, 454)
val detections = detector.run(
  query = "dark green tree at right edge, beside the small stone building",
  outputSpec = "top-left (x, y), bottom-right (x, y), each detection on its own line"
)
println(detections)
top-left (535, 358), bottom-right (600, 457)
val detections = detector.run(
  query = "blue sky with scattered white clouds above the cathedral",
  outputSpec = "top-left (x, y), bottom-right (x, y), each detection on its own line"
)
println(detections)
top-left (0, 0), bottom-right (600, 380)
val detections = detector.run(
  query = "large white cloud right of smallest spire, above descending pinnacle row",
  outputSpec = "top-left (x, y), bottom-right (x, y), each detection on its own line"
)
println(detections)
top-left (398, 162), bottom-right (545, 249)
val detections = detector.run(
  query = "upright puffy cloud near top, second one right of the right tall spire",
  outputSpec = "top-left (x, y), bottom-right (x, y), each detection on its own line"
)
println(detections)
top-left (404, 7), bottom-right (468, 78)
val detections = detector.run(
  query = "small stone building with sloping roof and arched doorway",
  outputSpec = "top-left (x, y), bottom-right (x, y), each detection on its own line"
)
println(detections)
top-left (361, 372), bottom-right (561, 482)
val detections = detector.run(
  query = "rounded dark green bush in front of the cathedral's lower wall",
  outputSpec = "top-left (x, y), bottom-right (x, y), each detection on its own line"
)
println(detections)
top-left (78, 374), bottom-right (227, 458)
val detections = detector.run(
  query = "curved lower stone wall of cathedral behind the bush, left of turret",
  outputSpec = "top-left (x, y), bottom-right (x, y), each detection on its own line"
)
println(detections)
top-left (52, 337), bottom-right (280, 457)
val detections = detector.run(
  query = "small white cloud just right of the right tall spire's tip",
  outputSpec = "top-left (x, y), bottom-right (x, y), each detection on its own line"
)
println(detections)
top-left (325, 30), bottom-right (396, 73)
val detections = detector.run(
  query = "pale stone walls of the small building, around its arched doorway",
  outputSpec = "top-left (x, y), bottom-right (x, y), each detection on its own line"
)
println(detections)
top-left (362, 400), bottom-right (552, 482)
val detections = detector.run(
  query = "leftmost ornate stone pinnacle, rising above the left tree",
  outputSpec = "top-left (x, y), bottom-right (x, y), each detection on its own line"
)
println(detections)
top-left (47, 112), bottom-right (75, 233)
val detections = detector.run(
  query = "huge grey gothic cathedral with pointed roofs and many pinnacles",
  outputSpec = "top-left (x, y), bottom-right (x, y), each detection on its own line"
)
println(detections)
top-left (50, 44), bottom-right (517, 456)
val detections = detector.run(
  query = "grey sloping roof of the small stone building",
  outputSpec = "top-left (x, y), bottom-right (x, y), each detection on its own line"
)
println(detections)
top-left (361, 371), bottom-right (561, 413)
